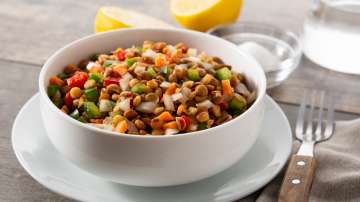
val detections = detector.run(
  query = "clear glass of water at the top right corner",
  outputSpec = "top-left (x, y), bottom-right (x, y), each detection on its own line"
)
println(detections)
top-left (303, 0), bottom-right (360, 74)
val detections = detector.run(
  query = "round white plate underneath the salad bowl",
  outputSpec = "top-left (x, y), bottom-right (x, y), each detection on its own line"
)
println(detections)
top-left (12, 94), bottom-right (292, 202)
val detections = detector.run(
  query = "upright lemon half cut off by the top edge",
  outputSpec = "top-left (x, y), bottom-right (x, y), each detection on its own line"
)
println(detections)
top-left (170, 0), bottom-right (243, 31)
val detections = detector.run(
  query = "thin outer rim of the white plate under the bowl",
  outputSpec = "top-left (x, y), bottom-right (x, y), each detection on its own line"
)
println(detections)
top-left (11, 92), bottom-right (294, 202)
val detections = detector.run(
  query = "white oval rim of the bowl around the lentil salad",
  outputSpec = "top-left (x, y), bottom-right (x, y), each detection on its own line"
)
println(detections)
top-left (38, 28), bottom-right (266, 139)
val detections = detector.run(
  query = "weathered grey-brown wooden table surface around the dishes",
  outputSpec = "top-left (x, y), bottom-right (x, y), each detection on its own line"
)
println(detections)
top-left (0, 0), bottom-right (360, 201)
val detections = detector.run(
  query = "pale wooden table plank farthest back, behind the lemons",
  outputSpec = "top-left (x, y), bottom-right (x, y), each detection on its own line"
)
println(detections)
top-left (0, 0), bottom-right (307, 64)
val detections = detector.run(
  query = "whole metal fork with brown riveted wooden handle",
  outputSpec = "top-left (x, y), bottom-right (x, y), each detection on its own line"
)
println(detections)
top-left (278, 90), bottom-right (334, 202)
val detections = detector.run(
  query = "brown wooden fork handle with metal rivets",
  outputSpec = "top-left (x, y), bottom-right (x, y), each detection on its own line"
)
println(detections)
top-left (278, 155), bottom-right (315, 202)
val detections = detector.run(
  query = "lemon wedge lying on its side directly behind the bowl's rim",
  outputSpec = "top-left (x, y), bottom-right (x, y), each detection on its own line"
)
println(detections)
top-left (95, 7), bottom-right (173, 32)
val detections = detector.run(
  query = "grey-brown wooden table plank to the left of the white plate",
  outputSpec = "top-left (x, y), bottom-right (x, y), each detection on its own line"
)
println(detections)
top-left (0, 61), bottom-right (69, 201)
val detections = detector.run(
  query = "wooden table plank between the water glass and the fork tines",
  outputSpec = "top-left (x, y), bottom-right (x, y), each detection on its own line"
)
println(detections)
top-left (269, 58), bottom-right (360, 114)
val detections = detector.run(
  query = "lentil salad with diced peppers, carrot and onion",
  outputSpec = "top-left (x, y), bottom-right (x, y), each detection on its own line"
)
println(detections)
top-left (48, 41), bottom-right (256, 135)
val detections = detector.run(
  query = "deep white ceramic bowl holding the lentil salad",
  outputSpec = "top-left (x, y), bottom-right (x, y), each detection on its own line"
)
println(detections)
top-left (39, 29), bottom-right (266, 186)
